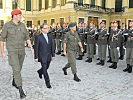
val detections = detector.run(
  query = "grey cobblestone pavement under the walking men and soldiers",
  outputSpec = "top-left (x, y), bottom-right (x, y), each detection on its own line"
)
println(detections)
top-left (0, 49), bottom-right (133, 100)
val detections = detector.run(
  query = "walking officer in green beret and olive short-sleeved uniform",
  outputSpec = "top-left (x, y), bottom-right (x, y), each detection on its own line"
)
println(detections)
top-left (63, 23), bottom-right (83, 82)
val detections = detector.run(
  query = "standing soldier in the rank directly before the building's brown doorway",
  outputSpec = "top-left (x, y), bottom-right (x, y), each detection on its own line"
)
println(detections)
top-left (86, 22), bottom-right (96, 63)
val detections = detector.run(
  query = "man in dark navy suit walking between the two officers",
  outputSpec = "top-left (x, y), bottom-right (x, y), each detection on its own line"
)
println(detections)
top-left (35, 24), bottom-right (55, 88)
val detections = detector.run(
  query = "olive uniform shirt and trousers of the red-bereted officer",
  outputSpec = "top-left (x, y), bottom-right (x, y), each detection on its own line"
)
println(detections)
top-left (1, 20), bottom-right (30, 86)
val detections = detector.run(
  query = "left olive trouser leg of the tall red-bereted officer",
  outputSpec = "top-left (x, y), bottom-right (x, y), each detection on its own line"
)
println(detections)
top-left (8, 52), bottom-right (22, 87)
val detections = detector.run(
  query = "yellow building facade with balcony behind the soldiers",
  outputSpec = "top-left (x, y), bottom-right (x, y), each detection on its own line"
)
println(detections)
top-left (0, 0), bottom-right (133, 27)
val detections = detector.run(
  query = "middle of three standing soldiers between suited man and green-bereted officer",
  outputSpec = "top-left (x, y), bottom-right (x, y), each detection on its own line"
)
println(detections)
top-left (56, 24), bottom-right (62, 55)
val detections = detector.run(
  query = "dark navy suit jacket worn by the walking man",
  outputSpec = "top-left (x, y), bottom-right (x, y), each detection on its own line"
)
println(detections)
top-left (34, 33), bottom-right (55, 63)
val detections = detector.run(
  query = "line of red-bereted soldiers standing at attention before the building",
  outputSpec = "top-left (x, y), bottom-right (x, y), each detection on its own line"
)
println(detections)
top-left (46, 20), bottom-right (133, 73)
